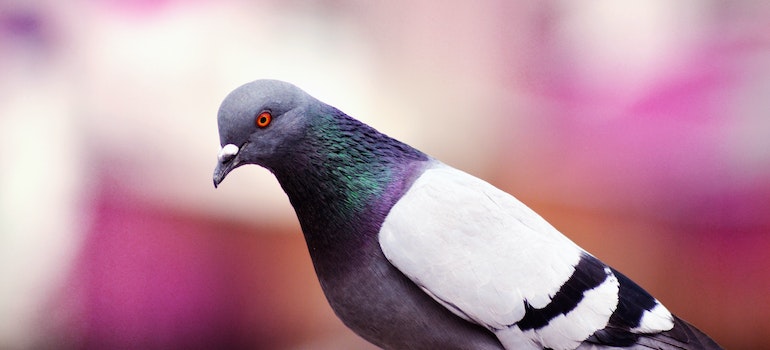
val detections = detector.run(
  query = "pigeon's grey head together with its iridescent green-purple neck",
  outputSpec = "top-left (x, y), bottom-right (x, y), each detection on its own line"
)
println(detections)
top-left (214, 80), bottom-right (430, 278)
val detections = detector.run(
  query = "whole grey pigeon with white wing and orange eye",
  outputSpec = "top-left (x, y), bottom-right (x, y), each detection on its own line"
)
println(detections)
top-left (213, 80), bottom-right (720, 350)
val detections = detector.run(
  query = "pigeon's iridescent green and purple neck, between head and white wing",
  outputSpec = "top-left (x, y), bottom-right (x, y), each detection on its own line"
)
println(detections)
top-left (272, 108), bottom-right (429, 268)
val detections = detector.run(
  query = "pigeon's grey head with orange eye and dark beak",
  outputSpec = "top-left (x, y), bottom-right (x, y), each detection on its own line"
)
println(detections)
top-left (214, 80), bottom-right (313, 187)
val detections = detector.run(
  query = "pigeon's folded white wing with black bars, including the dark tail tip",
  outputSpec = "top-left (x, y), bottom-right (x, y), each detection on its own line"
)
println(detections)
top-left (379, 162), bottom-right (719, 349)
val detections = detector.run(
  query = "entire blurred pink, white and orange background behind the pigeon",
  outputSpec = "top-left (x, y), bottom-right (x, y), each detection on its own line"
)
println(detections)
top-left (0, 0), bottom-right (770, 349)
